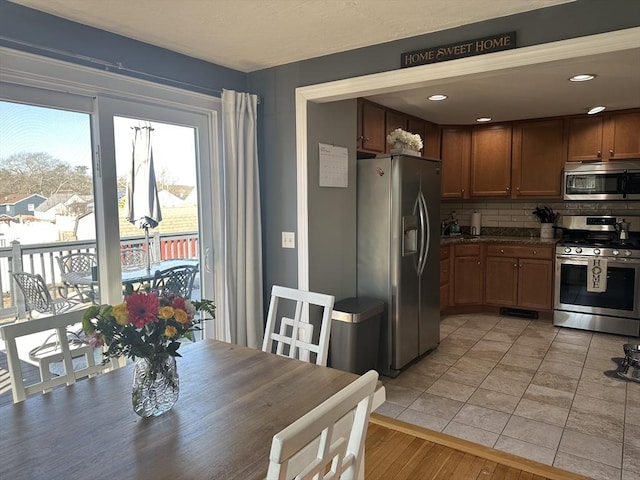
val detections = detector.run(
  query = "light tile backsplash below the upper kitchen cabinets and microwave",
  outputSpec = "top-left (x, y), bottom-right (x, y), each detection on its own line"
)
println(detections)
top-left (440, 200), bottom-right (640, 236)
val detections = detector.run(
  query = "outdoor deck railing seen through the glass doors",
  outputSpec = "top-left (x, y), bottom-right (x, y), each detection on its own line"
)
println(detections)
top-left (0, 232), bottom-right (198, 319)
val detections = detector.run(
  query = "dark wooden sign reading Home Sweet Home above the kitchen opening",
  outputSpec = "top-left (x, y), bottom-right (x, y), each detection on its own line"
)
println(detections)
top-left (400, 32), bottom-right (516, 68)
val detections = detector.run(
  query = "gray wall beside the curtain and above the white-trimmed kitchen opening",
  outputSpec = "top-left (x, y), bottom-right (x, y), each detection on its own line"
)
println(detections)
top-left (249, 0), bottom-right (640, 300)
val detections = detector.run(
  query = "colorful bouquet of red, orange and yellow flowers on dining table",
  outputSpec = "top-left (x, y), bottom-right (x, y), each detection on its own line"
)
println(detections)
top-left (82, 291), bottom-right (215, 363)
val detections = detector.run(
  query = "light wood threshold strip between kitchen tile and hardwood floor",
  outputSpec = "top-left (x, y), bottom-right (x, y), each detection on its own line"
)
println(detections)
top-left (367, 413), bottom-right (591, 480)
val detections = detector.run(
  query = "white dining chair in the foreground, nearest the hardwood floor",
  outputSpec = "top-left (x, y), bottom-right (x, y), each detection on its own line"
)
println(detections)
top-left (267, 370), bottom-right (378, 480)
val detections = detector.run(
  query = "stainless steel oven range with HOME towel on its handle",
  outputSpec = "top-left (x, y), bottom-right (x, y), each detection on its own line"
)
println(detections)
top-left (554, 217), bottom-right (640, 336)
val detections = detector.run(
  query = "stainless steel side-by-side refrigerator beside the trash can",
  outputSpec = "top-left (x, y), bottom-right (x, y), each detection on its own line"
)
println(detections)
top-left (357, 154), bottom-right (440, 376)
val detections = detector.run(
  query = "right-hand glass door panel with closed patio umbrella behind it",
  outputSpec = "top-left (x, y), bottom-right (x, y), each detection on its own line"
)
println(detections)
top-left (96, 98), bottom-right (214, 326)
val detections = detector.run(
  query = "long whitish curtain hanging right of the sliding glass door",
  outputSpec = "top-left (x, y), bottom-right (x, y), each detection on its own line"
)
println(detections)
top-left (214, 90), bottom-right (264, 348)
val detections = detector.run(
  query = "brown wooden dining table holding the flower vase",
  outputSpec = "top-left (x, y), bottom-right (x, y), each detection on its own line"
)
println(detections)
top-left (0, 339), bottom-right (357, 480)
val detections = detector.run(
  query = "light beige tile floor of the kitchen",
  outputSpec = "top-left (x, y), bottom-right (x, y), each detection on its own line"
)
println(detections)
top-left (376, 314), bottom-right (640, 480)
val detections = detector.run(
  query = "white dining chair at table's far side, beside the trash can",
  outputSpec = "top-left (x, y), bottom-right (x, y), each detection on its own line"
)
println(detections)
top-left (262, 285), bottom-right (335, 366)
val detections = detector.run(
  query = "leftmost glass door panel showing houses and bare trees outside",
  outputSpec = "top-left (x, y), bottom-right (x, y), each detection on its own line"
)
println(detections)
top-left (0, 82), bottom-right (96, 319)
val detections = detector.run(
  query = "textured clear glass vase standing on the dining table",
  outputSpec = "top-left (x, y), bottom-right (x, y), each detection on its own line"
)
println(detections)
top-left (131, 356), bottom-right (180, 417)
